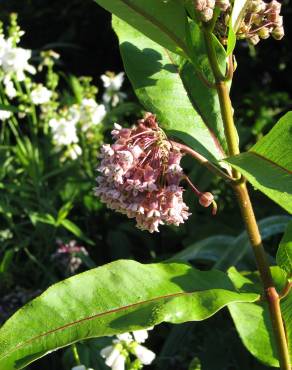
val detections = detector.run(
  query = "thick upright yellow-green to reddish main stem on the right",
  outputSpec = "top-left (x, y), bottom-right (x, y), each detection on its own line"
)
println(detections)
top-left (204, 28), bottom-right (291, 370)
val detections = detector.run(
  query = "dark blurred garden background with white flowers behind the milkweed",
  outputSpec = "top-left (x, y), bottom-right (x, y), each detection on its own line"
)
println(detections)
top-left (0, 0), bottom-right (292, 370)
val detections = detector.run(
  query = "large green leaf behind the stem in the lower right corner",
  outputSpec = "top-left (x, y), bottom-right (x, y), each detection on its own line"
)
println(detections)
top-left (228, 267), bottom-right (292, 367)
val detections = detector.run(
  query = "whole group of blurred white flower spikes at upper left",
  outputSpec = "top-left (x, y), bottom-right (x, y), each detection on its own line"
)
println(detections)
top-left (0, 14), bottom-right (126, 160)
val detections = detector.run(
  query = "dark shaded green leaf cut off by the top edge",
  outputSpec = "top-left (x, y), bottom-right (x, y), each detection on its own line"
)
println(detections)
top-left (95, 0), bottom-right (189, 56)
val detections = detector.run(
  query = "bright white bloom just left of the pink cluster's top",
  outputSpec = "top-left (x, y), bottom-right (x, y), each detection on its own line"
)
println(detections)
top-left (49, 117), bottom-right (78, 145)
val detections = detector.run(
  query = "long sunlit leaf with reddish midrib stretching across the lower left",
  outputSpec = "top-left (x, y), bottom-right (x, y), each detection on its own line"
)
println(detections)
top-left (0, 260), bottom-right (259, 370)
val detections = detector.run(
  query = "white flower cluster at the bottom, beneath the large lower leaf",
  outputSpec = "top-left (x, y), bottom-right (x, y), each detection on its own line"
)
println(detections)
top-left (100, 328), bottom-right (155, 370)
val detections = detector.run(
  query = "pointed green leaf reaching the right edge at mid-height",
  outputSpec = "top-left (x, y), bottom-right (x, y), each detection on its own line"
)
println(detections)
top-left (226, 112), bottom-right (292, 213)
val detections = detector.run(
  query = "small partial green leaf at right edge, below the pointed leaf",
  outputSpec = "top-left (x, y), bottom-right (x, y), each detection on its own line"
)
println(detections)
top-left (276, 222), bottom-right (292, 277)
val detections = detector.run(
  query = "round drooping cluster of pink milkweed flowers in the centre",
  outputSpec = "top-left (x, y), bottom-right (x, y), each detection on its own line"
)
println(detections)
top-left (95, 113), bottom-right (190, 233)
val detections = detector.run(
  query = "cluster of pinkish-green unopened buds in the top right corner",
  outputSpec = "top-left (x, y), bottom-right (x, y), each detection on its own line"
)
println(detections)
top-left (237, 0), bottom-right (284, 45)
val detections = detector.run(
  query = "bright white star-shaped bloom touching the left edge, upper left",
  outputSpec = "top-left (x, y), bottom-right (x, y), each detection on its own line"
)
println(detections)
top-left (1, 42), bottom-right (36, 81)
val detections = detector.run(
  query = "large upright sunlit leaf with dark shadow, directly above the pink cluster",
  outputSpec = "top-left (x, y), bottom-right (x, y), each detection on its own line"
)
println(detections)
top-left (113, 17), bottom-right (225, 161)
